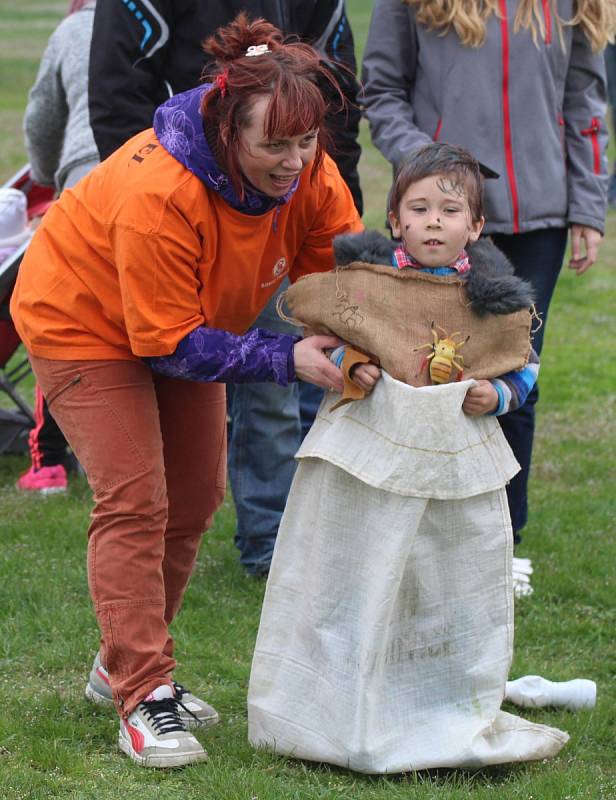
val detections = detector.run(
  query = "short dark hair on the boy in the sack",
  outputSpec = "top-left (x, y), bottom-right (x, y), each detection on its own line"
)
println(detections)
top-left (388, 142), bottom-right (483, 222)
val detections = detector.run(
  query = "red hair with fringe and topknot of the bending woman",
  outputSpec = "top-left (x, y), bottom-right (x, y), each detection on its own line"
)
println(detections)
top-left (201, 12), bottom-right (343, 197)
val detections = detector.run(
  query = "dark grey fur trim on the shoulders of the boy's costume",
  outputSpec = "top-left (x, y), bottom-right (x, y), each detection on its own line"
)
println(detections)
top-left (334, 231), bottom-right (533, 317)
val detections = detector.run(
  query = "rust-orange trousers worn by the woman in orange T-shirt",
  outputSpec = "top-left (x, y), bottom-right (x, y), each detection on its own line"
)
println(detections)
top-left (31, 356), bottom-right (226, 716)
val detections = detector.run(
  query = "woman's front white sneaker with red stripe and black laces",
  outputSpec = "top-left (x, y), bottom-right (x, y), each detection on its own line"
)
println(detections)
top-left (118, 684), bottom-right (207, 768)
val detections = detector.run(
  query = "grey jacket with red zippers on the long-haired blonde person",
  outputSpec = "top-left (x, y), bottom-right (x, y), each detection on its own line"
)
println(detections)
top-left (363, 0), bottom-right (608, 234)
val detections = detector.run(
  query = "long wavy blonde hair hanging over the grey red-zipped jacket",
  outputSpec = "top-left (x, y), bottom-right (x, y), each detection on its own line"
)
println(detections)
top-left (403, 0), bottom-right (616, 52)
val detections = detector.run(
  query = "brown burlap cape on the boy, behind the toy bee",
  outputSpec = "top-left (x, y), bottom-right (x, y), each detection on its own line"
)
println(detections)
top-left (285, 262), bottom-right (532, 387)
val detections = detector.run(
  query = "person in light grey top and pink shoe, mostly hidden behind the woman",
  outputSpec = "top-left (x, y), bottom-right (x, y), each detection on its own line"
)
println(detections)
top-left (17, 0), bottom-right (99, 494)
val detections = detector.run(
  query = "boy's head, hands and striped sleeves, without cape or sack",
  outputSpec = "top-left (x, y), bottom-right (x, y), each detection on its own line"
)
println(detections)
top-left (331, 142), bottom-right (539, 428)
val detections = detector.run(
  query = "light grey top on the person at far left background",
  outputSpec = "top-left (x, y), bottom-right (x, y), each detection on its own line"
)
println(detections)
top-left (24, 0), bottom-right (98, 189)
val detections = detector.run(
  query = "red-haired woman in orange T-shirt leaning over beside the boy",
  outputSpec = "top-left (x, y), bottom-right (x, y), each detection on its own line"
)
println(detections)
top-left (11, 16), bottom-right (371, 767)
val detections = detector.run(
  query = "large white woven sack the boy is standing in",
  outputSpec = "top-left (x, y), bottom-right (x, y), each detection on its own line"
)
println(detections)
top-left (248, 374), bottom-right (568, 773)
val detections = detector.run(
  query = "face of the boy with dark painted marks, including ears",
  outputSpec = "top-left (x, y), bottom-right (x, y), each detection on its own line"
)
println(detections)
top-left (389, 175), bottom-right (484, 267)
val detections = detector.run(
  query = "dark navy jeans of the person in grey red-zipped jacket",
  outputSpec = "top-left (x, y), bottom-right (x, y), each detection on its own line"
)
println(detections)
top-left (492, 228), bottom-right (567, 544)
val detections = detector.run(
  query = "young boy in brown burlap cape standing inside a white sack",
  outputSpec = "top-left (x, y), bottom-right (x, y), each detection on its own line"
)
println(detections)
top-left (248, 144), bottom-right (567, 773)
